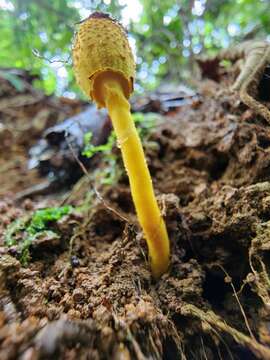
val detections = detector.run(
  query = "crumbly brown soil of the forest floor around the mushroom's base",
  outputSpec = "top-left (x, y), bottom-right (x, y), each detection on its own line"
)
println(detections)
top-left (0, 60), bottom-right (270, 360)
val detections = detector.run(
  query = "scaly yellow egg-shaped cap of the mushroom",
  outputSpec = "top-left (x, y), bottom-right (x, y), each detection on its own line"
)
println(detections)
top-left (73, 13), bottom-right (135, 108)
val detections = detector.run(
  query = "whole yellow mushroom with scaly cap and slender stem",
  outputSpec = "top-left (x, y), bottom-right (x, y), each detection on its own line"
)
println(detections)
top-left (73, 13), bottom-right (170, 278)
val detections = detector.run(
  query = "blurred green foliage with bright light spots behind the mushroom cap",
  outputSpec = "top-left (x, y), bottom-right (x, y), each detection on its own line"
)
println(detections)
top-left (0, 0), bottom-right (270, 96)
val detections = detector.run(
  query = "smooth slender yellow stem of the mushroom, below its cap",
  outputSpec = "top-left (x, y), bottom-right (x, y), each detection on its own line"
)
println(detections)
top-left (103, 81), bottom-right (170, 278)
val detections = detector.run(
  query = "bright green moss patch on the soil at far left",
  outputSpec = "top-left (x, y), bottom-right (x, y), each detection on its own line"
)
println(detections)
top-left (4, 205), bottom-right (73, 266)
